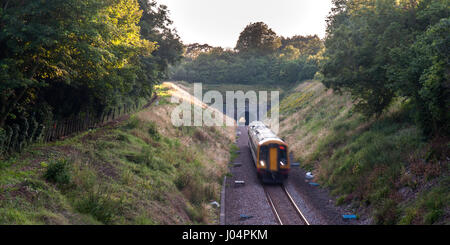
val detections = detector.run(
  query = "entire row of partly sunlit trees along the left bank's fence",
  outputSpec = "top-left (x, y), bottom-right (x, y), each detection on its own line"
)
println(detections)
top-left (0, 0), bottom-right (183, 154)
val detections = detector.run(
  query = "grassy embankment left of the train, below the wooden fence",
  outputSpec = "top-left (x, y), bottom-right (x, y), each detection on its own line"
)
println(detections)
top-left (0, 82), bottom-right (234, 224)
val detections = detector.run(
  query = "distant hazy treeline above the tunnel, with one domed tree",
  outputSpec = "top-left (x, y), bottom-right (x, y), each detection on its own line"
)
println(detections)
top-left (170, 22), bottom-right (323, 85)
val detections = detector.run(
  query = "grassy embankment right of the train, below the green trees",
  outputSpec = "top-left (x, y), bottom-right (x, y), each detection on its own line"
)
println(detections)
top-left (280, 81), bottom-right (450, 224)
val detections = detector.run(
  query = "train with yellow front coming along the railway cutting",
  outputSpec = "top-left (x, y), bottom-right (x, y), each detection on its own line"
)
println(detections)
top-left (248, 121), bottom-right (291, 183)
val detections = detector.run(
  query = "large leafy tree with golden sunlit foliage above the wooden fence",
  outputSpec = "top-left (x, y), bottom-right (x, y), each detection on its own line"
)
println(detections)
top-left (0, 0), bottom-right (156, 127)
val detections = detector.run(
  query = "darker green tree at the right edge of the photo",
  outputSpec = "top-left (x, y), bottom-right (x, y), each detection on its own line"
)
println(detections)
top-left (389, 15), bottom-right (450, 135)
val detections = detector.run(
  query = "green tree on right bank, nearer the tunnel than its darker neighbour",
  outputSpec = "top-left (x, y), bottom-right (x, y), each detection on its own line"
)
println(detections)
top-left (321, 0), bottom-right (402, 116)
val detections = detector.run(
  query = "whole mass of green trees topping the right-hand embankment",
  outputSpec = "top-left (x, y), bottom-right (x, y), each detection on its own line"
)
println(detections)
top-left (321, 0), bottom-right (450, 136)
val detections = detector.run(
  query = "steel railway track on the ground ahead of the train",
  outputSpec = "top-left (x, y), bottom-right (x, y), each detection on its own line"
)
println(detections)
top-left (264, 185), bottom-right (310, 225)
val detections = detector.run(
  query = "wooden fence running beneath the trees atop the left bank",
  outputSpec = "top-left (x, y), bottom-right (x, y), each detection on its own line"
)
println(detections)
top-left (0, 94), bottom-right (158, 156)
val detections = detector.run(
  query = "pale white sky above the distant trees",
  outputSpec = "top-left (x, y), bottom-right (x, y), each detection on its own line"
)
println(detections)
top-left (157, 0), bottom-right (331, 48)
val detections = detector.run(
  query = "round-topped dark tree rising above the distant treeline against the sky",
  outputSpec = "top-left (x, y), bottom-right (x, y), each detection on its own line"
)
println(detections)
top-left (235, 22), bottom-right (281, 55)
